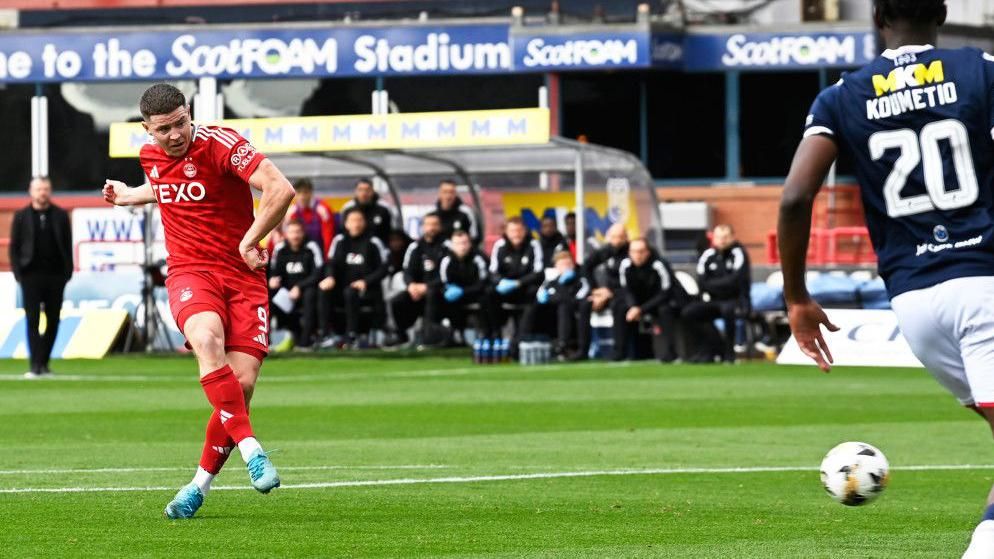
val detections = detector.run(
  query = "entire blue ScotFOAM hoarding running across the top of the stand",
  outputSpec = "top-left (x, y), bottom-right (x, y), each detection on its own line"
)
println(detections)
top-left (0, 24), bottom-right (877, 83)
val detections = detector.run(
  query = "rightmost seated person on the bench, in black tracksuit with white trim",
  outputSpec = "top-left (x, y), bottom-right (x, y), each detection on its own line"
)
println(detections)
top-left (683, 225), bottom-right (752, 362)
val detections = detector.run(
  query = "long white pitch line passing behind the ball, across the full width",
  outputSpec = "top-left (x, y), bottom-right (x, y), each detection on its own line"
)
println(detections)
top-left (0, 464), bottom-right (994, 494)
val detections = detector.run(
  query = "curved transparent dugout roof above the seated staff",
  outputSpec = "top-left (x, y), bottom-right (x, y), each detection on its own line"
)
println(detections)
top-left (269, 137), bottom-right (663, 254)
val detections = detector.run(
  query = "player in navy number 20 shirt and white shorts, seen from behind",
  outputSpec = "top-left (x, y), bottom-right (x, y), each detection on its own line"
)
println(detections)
top-left (778, 0), bottom-right (994, 559)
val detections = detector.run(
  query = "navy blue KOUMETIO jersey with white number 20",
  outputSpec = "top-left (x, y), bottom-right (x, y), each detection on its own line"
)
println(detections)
top-left (804, 45), bottom-right (994, 297)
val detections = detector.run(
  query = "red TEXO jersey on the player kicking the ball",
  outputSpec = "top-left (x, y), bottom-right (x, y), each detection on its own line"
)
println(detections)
top-left (140, 125), bottom-right (266, 276)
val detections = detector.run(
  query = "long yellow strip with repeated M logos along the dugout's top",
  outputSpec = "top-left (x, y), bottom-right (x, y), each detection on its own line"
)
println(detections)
top-left (110, 109), bottom-right (549, 157)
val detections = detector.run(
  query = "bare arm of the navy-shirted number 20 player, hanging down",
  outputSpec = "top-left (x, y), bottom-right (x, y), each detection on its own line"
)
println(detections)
top-left (777, 135), bottom-right (839, 373)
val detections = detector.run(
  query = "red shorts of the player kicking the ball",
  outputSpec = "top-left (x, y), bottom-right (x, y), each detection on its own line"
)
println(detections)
top-left (166, 270), bottom-right (269, 361)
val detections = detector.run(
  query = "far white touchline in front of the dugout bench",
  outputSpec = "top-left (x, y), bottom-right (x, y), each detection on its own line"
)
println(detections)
top-left (0, 362), bottom-right (631, 385)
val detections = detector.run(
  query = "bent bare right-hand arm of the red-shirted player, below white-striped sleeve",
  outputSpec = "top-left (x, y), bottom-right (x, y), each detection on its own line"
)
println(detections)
top-left (238, 159), bottom-right (296, 270)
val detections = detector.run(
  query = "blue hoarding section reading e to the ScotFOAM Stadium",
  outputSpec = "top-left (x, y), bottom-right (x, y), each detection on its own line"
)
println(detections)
top-left (0, 24), bottom-right (512, 83)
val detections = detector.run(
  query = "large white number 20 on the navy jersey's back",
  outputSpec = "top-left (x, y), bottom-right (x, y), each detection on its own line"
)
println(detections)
top-left (870, 119), bottom-right (980, 217)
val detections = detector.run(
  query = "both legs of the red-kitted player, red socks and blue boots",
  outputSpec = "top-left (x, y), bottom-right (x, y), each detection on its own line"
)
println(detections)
top-left (165, 312), bottom-right (280, 518)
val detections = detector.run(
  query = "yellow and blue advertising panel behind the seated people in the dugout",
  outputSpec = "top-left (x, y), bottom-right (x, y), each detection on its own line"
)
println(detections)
top-left (503, 191), bottom-right (641, 239)
